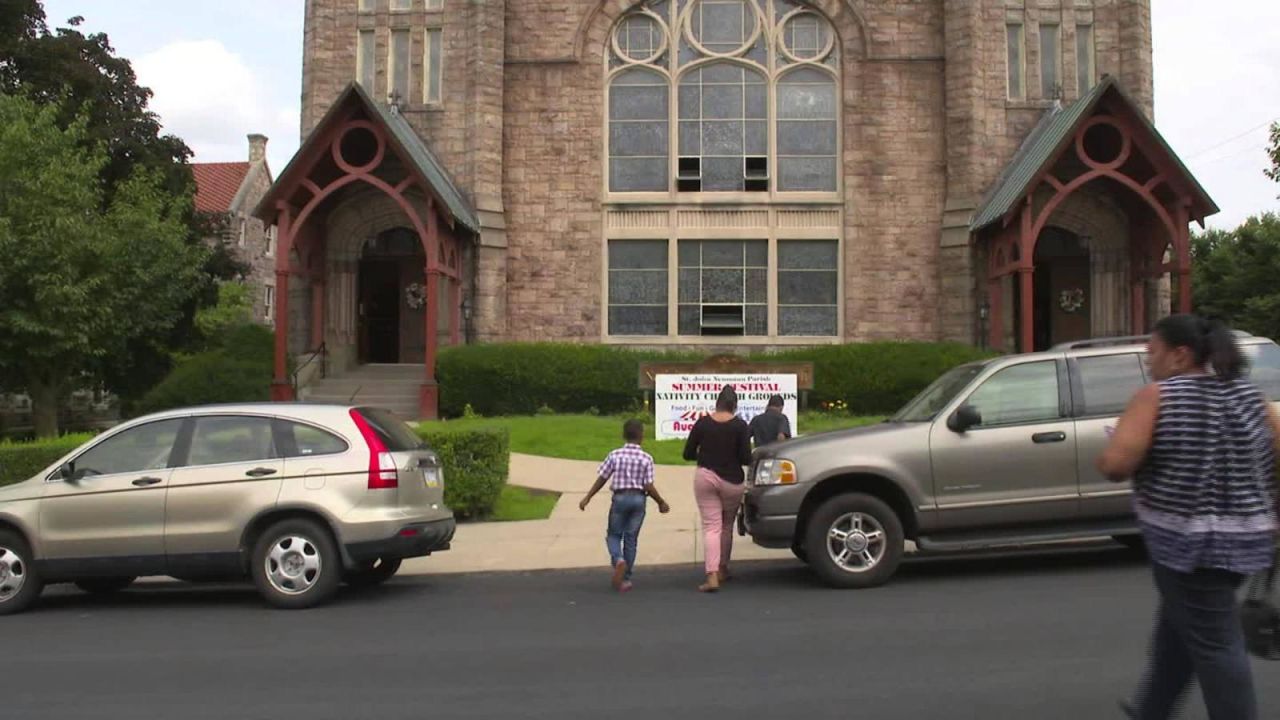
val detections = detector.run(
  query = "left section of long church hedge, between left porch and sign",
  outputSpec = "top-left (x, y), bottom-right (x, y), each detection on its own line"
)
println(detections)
top-left (436, 343), bottom-right (701, 418)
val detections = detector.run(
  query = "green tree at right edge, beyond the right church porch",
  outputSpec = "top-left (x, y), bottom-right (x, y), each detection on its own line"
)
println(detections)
top-left (1192, 213), bottom-right (1280, 338)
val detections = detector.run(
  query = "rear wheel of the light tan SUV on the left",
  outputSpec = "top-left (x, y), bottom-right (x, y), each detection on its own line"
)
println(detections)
top-left (250, 519), bottom-right (342, 610)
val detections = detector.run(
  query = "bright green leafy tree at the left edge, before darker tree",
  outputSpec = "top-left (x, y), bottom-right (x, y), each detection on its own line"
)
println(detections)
top-left (0, 94), bottom-right (206, 437)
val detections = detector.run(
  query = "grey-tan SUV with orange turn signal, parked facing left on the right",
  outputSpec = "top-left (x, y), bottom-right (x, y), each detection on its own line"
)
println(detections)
top-left (744, 333), bottom-right (1280, 588)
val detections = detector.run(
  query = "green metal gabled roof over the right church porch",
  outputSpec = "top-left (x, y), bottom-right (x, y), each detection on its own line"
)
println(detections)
top-left (969, 76), bottom-right (1217, 232)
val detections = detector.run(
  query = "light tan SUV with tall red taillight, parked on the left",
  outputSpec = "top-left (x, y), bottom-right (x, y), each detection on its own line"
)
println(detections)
top-left (0, 404), bottom-right (454, 615)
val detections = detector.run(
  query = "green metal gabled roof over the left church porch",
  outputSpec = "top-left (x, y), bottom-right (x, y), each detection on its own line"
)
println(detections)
top-left (253, 82), bottom-right (480, 234)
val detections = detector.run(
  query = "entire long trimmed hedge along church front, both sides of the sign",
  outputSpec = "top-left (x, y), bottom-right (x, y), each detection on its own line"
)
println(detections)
top-left (436, 342), bottom-right (989, 418)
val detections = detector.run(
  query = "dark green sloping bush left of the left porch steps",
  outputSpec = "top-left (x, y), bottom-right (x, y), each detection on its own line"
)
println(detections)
top-left (138, 324), bottom-right (275, 414)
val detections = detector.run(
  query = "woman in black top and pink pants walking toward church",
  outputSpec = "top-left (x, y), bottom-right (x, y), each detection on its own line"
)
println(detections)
top-left (685, 386), bottom-right (751, 592)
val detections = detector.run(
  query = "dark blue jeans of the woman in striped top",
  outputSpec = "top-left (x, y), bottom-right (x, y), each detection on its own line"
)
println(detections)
top-left (1135, 564), bottom-right (1258, 720)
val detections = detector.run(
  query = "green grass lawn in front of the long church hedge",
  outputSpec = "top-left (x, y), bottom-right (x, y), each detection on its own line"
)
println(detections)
top-left (419, 413), bottom-right (881, 465)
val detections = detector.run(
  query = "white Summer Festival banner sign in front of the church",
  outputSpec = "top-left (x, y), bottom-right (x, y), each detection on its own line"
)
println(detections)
top-left (653, 374), bottom-right (800, 439)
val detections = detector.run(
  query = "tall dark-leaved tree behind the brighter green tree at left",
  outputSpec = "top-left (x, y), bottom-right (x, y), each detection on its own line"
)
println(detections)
top-left (0, 0), bottom-right (247, 410)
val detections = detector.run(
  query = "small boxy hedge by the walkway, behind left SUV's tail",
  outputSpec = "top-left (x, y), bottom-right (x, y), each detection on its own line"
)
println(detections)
top-left (417, 425), bottom-right (511, 518)
